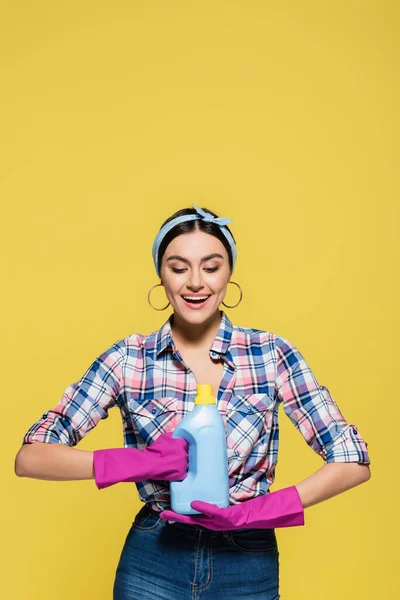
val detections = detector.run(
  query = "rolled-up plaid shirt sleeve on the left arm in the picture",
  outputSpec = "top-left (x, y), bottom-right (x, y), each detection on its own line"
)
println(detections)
top-left (22, 340), bottom-right (125, 446)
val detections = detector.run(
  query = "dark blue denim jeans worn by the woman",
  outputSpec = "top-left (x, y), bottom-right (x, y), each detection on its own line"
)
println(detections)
top-left (113, 504), bottom-right (280, 600)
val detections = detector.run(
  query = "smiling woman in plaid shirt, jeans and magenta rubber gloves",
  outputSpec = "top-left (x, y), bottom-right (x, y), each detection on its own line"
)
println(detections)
top-left (16, 205), bottom-right (370, 600)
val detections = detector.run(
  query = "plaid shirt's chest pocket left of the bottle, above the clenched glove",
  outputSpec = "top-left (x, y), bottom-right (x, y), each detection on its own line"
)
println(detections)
top-left (127, 396), bottom-right (178, 445)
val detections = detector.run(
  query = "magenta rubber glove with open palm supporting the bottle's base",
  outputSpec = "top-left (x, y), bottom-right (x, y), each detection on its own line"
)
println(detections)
top-left (160, 485), bottom-right (304, 531)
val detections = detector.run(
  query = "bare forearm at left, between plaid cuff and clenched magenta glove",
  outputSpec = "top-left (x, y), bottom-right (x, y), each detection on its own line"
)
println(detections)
top-left (14, 442), bottom-right (94, 481)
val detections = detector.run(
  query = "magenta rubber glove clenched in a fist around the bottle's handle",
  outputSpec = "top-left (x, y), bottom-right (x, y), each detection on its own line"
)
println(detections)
top-left (93, 431), bottom-right (189, 490)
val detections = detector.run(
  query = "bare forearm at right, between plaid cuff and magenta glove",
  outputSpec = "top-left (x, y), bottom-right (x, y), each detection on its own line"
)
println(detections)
top-left (296, 462), bottom-right (371, 508)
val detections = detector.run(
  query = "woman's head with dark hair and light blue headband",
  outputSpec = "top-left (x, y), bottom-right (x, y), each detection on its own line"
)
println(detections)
top-left (153, 205), bottom-right (242, 338)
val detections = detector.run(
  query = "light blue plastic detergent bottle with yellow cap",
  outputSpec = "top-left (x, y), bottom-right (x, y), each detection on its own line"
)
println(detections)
top-left (170, 384), bottom-right (229, 515)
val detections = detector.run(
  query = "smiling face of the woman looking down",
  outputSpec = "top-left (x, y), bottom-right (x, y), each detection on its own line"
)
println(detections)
top-left (160, 230), bottom-right (231, 324)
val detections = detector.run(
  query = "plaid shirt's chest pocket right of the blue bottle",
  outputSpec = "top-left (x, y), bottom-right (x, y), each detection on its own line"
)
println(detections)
top-left (225, 394), bottom-right (275, 459)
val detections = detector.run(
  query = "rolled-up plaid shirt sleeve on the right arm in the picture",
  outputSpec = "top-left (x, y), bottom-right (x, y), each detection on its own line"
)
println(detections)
top-left (275, 336), bottom-right (370, 464)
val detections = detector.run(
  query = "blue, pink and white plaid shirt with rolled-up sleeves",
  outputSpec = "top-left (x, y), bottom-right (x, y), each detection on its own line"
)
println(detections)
top-left (23, 311), bottom-right (370, 510)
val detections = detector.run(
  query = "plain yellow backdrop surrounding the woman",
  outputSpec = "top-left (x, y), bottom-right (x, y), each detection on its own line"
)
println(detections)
top-left (0, 0), bottom-right (400, 600)
